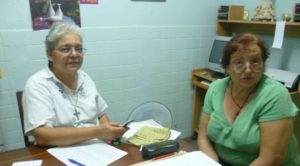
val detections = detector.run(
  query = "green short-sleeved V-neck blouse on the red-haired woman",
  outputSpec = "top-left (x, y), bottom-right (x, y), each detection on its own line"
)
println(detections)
top-left (203, 75), bottom-right (300, 166)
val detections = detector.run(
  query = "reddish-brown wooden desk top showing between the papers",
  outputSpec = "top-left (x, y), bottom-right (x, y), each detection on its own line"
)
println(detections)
top-left (0, 140), bottom-right (196, 166)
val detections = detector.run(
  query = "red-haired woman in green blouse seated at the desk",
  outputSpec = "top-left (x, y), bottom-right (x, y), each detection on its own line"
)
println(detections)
top-left (198, 33), bottom-right (300, 166)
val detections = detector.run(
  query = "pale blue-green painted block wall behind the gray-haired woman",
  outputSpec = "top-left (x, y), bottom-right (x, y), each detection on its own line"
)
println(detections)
top-left (0, 0), bottom-right (219, 150)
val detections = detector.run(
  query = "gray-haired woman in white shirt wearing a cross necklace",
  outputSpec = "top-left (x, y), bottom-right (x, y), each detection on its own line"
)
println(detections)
top-left (23, 22), bottom-right (126, 146)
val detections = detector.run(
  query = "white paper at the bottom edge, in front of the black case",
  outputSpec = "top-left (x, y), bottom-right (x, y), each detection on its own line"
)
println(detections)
top-left (143, 151), bottom-right (221, 166)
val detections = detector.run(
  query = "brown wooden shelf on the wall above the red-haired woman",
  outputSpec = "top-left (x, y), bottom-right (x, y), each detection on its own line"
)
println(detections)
top-left (217, 20), bottom-right (300, 38)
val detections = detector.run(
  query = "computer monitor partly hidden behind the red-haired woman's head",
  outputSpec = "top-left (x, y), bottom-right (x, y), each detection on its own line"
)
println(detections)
top-left (207, 36), bottom-right (231, 73)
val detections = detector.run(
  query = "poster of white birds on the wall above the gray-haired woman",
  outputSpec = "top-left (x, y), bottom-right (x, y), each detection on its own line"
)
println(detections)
top-left (29, 0), bottom-right (81, 30)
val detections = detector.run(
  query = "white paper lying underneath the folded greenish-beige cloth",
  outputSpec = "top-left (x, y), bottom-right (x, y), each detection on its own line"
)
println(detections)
top-left (121, 119), bottom-right (181, 143)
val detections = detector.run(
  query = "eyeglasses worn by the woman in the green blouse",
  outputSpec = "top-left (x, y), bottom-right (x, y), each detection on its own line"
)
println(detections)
top-left (231, 59), bottom-right (263, 72)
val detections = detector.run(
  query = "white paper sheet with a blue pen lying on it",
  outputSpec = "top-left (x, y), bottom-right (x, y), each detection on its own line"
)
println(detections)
top-left (47, 139), bottom-right (127, 166)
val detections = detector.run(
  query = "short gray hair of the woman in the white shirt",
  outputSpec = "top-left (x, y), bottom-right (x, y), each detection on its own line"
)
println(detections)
top-left (45, 21), bottom-right (82, 52)
